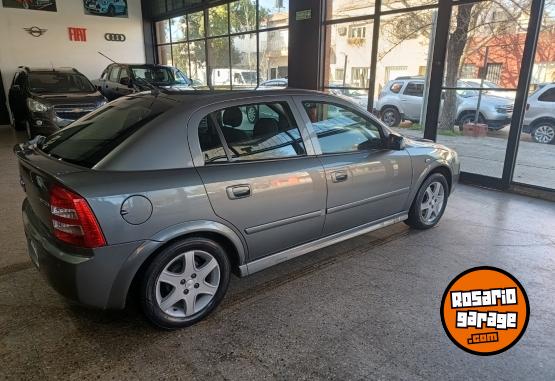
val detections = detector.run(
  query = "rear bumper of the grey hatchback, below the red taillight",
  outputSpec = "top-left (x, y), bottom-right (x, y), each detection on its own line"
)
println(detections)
top-left (22, 199), bottom-right (143, 309)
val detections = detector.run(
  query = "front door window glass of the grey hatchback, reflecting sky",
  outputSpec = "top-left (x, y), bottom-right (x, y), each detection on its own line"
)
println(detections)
top-left (303, 102), bottom-right (382, 154)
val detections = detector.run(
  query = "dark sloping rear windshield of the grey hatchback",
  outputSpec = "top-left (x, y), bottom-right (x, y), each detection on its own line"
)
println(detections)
top-left (41, 95), bottom-right (175, 168)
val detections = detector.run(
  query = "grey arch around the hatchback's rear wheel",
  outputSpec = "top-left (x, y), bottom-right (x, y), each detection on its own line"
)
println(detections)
top-left (108, 221), bottom-right (247, 309)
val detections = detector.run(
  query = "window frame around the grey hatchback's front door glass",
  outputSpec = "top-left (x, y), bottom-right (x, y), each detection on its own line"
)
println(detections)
top-left (295, 96), bottom-right (389, 157)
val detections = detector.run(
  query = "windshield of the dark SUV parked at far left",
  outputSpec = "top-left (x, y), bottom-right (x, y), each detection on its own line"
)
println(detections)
top-left (28, 72), bottom-right (96, 94)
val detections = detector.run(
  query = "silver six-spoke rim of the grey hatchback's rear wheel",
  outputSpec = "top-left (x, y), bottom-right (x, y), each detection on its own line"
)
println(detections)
top-left (156, 250), bottom-right (221, 318)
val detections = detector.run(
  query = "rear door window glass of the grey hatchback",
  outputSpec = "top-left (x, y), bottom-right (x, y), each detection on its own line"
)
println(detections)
top-left (199, 102), bottom-right (306, 164)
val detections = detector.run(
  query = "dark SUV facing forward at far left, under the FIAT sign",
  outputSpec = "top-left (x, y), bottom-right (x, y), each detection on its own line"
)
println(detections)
top-left (9, 66), bottom-right (106, 138)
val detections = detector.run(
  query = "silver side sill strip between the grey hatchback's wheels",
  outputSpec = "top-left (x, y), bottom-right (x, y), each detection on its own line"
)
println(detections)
top-left (239, 212), bottom-right (408, 276)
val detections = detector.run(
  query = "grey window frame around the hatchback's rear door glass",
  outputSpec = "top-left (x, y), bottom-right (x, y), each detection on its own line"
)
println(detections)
top-left (187, 95), bottom-right (315, 167)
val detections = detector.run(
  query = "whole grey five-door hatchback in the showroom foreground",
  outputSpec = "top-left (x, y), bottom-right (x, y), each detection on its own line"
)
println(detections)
top-left (15, 90), bottom-right (459, 329)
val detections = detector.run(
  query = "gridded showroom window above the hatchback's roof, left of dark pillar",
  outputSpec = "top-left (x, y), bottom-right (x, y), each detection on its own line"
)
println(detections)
top-left (154, 0), bottom-right (289, 90)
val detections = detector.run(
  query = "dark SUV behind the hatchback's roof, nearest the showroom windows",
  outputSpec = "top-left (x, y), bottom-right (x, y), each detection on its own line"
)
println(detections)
top-left (93, 63), bottom-right (194, 100)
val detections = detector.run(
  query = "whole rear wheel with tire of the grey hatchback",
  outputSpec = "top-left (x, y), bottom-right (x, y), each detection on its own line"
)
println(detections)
top-left (141, 238), bottom-right (231, 330)
